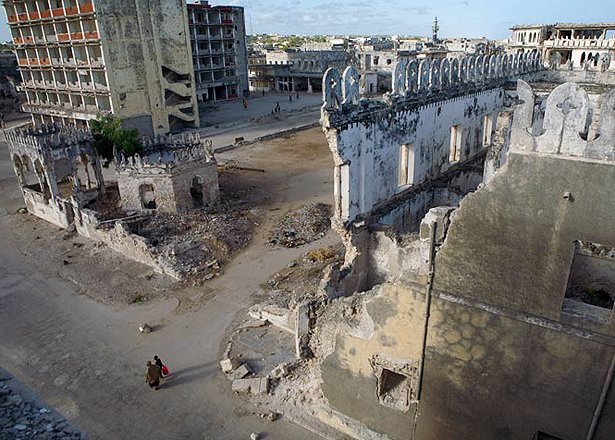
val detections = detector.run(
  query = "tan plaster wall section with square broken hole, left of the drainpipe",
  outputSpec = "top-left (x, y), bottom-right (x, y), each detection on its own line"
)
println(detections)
top-left (313, 283), bottom-right (424, 439)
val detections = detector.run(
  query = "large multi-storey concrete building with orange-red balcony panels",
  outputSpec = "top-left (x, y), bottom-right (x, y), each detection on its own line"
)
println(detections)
top-left (2, 0), bottom-right (199, 135)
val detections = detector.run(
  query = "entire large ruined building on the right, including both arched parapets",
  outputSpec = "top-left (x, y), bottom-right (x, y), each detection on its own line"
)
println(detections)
top-left (310, 53), bottom-right (615, 440)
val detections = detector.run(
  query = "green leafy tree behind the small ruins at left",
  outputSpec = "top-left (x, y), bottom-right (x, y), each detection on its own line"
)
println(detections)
top-left (90, 115), bottom-right (143, 166)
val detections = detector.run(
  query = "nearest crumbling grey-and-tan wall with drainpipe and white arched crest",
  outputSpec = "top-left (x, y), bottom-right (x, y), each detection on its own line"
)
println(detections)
top-left (313, 83), bottom-right (615, 440)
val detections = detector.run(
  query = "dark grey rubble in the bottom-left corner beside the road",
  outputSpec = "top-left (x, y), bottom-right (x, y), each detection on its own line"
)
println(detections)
top-left (0, 372), bottom-right (85, 440)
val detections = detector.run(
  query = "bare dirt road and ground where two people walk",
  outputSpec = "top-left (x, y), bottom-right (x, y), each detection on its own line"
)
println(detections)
top-left (0, 125), bottom-right (339, 439)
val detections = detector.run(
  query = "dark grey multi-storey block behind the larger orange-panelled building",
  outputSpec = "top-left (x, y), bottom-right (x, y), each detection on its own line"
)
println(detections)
top-left (188, 1), bottom-right (249, 101)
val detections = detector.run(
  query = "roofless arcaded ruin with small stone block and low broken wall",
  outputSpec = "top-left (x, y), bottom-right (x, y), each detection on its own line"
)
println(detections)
top-left (6, 124), bottom-right (219, 280)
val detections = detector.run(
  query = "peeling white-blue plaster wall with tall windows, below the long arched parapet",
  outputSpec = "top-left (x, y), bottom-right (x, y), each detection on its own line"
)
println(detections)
top-left (332, 88), bottom-right (504, 225)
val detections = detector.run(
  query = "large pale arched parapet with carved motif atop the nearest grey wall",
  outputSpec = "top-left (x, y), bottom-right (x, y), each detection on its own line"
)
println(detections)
top-left (510, 80), bottom-right (615, 161)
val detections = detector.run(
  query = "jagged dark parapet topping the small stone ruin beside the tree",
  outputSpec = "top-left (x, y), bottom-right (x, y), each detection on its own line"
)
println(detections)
top-left (115, 133), bottom-right (215, 174)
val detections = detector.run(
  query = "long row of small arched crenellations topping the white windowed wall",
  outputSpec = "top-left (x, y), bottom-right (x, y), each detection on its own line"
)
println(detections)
top-left (322, 52), bottom-right (543, 124)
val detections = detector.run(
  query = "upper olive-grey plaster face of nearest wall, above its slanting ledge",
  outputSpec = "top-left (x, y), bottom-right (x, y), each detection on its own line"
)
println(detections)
top-left (435, 153), bottom-right (615, 335)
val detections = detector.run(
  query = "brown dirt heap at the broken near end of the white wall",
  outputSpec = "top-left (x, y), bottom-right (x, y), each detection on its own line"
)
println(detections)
top-left (261, 243), bottom-right (345, 308)
